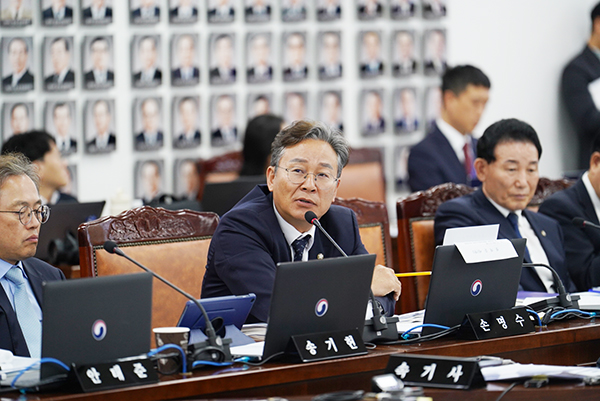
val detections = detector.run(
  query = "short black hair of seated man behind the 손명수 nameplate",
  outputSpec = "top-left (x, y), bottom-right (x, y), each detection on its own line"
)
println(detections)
top-left (477, 118), bottom-right (542, 163)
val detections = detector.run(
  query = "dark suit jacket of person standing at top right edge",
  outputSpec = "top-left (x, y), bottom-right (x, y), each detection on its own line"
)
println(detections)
top-left (561, 45), bottom-right (600, 170)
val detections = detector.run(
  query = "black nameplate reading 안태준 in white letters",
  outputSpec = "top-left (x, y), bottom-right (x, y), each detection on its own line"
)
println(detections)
top-left (73, 356), bottom-right (158, 393)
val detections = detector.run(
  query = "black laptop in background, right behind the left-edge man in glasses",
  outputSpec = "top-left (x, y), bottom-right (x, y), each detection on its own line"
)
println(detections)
top-left (35, 201), bottom-right (106, 262)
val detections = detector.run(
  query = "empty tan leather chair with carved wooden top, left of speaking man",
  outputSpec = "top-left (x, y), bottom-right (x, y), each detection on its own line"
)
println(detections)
top-left (78, 206), bottom-right (219, 344)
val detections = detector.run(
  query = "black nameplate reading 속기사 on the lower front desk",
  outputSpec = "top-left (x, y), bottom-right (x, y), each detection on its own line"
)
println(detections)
top-left (385, 354), bottom-right (485, 390)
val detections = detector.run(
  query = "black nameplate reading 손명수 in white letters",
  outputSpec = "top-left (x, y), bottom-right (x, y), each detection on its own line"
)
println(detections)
top-left (460, 306), bottom-right (535, 340)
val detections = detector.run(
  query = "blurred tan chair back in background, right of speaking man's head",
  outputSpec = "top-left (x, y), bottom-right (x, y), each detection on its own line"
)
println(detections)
top-left (337, 148), bottom-right (386, 202)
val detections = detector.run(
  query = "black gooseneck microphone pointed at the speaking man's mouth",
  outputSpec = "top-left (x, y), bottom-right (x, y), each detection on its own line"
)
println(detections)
top-left (304, 210), bottom-right (398, 342)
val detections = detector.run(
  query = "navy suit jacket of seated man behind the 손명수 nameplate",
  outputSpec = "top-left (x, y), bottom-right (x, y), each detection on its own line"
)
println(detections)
top-left (434, 188), bottom-right (575, 292)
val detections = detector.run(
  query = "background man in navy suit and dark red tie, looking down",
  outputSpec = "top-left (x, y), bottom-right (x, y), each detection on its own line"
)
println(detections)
top-left (408, 65), bottom-right (491, 191)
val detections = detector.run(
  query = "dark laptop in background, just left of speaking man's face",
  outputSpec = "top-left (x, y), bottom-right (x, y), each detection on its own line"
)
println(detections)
top-left (202, 175), bottom-right (267, 216)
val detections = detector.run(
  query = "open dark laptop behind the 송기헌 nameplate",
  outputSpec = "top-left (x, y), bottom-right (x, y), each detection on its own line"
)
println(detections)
top-left (231, 255), bottom-right (376, 359)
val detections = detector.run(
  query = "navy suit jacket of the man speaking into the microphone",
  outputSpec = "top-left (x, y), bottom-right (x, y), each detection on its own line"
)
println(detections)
top-left (202, 185), bottom-right (394, 322)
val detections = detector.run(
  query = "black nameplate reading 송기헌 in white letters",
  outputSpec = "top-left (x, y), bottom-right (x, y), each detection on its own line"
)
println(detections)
top-left (292, 328), bottom-right (367, 362)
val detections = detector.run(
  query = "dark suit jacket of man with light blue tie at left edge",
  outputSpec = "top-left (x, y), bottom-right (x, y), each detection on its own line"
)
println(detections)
top-left (0, 258), bottom-right (65, 357)
